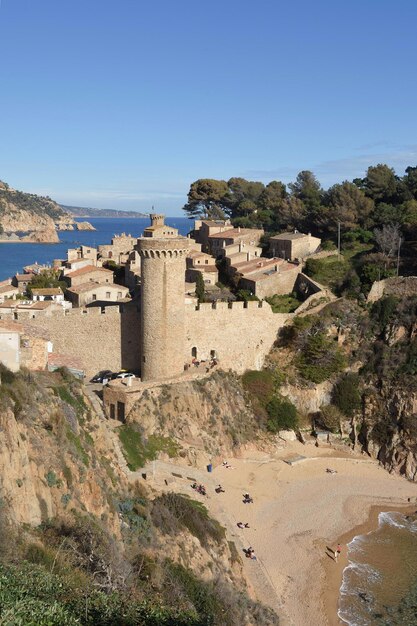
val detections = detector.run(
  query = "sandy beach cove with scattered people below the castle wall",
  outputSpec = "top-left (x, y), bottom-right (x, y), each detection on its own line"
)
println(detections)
top-left (196, 442), bottom-right (417, 626)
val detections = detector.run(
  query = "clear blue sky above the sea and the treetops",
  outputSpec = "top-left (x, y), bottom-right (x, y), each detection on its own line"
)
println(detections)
top-left (0, 0), bottom-right (417, 215)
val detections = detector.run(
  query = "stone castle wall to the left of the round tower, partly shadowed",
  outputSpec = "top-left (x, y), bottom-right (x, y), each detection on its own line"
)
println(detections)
top-left (2, 306), bottom-right (140, 378)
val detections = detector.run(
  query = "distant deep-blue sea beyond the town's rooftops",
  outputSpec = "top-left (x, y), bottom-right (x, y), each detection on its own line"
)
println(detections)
top-left (0, 217), bottom-right (193, 280)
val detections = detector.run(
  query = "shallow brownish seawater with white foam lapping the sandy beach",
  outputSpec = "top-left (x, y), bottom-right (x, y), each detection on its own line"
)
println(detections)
top-left (339, 513), bottom-right (417, 626)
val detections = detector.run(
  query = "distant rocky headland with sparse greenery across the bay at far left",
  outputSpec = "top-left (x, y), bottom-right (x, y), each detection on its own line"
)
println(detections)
top-left (0, 181), bottom-right (74, 232)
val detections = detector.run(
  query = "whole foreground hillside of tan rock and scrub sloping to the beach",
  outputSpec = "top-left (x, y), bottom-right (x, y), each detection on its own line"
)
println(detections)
top-left (0, 367), bottom-right (278, 626)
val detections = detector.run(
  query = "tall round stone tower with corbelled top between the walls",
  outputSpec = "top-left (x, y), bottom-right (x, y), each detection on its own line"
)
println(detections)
top-left (137, 237), bottom-right (189, 381)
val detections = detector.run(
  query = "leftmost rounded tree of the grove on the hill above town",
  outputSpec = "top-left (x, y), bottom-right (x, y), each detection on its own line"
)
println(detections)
top-left (183, 178), bottom-right (229, 219)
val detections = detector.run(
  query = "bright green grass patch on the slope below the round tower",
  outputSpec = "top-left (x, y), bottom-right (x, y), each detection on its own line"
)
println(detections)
top-left (118, 424), bottom-right (180, 471)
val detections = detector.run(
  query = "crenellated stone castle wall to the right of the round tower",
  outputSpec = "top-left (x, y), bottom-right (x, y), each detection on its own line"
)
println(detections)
top-left (184, 302), bottom-right (292, 373)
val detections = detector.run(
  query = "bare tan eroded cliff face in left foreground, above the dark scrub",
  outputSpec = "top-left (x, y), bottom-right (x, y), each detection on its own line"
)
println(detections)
top-left (0, 370), bottom-right (124, 532)
